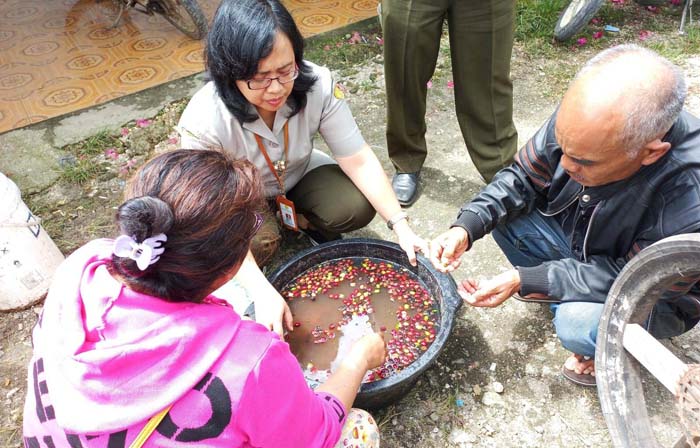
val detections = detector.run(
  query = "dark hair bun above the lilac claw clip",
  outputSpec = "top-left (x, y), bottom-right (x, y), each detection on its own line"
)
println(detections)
top-left (116, 196), bottom-right (175, 242)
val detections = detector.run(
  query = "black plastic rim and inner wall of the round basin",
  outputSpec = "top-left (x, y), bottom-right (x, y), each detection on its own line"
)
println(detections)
top-left (268, 238), bottom-right (462, 409)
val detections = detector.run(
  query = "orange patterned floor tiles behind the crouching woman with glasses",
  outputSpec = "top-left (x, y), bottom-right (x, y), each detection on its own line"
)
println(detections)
top-left (0, 0), bottom-right (378, 133)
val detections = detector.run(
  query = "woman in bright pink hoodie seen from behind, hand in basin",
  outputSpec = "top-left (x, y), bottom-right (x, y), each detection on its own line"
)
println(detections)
top-left (23, 150), bottom-right (385, 448)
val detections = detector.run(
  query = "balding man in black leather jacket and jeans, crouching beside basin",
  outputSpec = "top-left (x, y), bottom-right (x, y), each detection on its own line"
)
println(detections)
top-left (431, 45), bottom-right (700, 385)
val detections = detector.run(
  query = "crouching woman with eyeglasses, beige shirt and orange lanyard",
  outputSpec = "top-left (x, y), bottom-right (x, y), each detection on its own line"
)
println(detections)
top-left (178, 0), bottom-right (427, 332)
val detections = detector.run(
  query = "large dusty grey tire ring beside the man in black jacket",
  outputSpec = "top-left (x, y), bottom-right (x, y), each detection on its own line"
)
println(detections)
top-left (595, 234), bottom-right (700, 448)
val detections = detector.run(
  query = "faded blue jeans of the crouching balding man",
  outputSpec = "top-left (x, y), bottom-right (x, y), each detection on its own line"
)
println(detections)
top-left (491, 211), bottom-right (603, 356)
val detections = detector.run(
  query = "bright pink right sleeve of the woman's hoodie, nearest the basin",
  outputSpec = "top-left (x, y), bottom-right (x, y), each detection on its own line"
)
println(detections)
top-left (234, 341), bottom-right (346, 448)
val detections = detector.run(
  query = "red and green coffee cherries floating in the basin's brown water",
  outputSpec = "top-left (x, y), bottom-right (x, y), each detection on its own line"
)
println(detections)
top-left (282, 258), bottom-right (440, 382)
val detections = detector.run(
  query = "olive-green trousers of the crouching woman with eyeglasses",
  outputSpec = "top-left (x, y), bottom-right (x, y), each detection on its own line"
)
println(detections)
top-left (250, 164), bottom-right (376, 266)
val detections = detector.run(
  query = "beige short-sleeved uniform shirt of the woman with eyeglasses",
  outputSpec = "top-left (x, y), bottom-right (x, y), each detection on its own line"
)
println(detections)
top-left (178, 62), bottom-right (365, 197)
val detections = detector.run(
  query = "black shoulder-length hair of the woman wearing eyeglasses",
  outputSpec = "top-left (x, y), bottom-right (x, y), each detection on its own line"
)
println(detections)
top-left (205, 0), bottom-right (316, 123)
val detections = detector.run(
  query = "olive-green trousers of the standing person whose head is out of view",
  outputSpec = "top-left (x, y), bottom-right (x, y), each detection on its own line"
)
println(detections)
top-left (382, 0), bottom-right (518, 182)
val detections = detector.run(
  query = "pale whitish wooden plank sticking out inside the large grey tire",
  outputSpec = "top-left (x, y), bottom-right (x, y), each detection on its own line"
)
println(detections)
top-left (622, 324), bottom-right (688, 395)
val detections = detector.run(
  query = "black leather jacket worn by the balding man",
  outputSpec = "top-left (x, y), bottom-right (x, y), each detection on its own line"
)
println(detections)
top-left (453, 111), bottom-right (700, 302)
